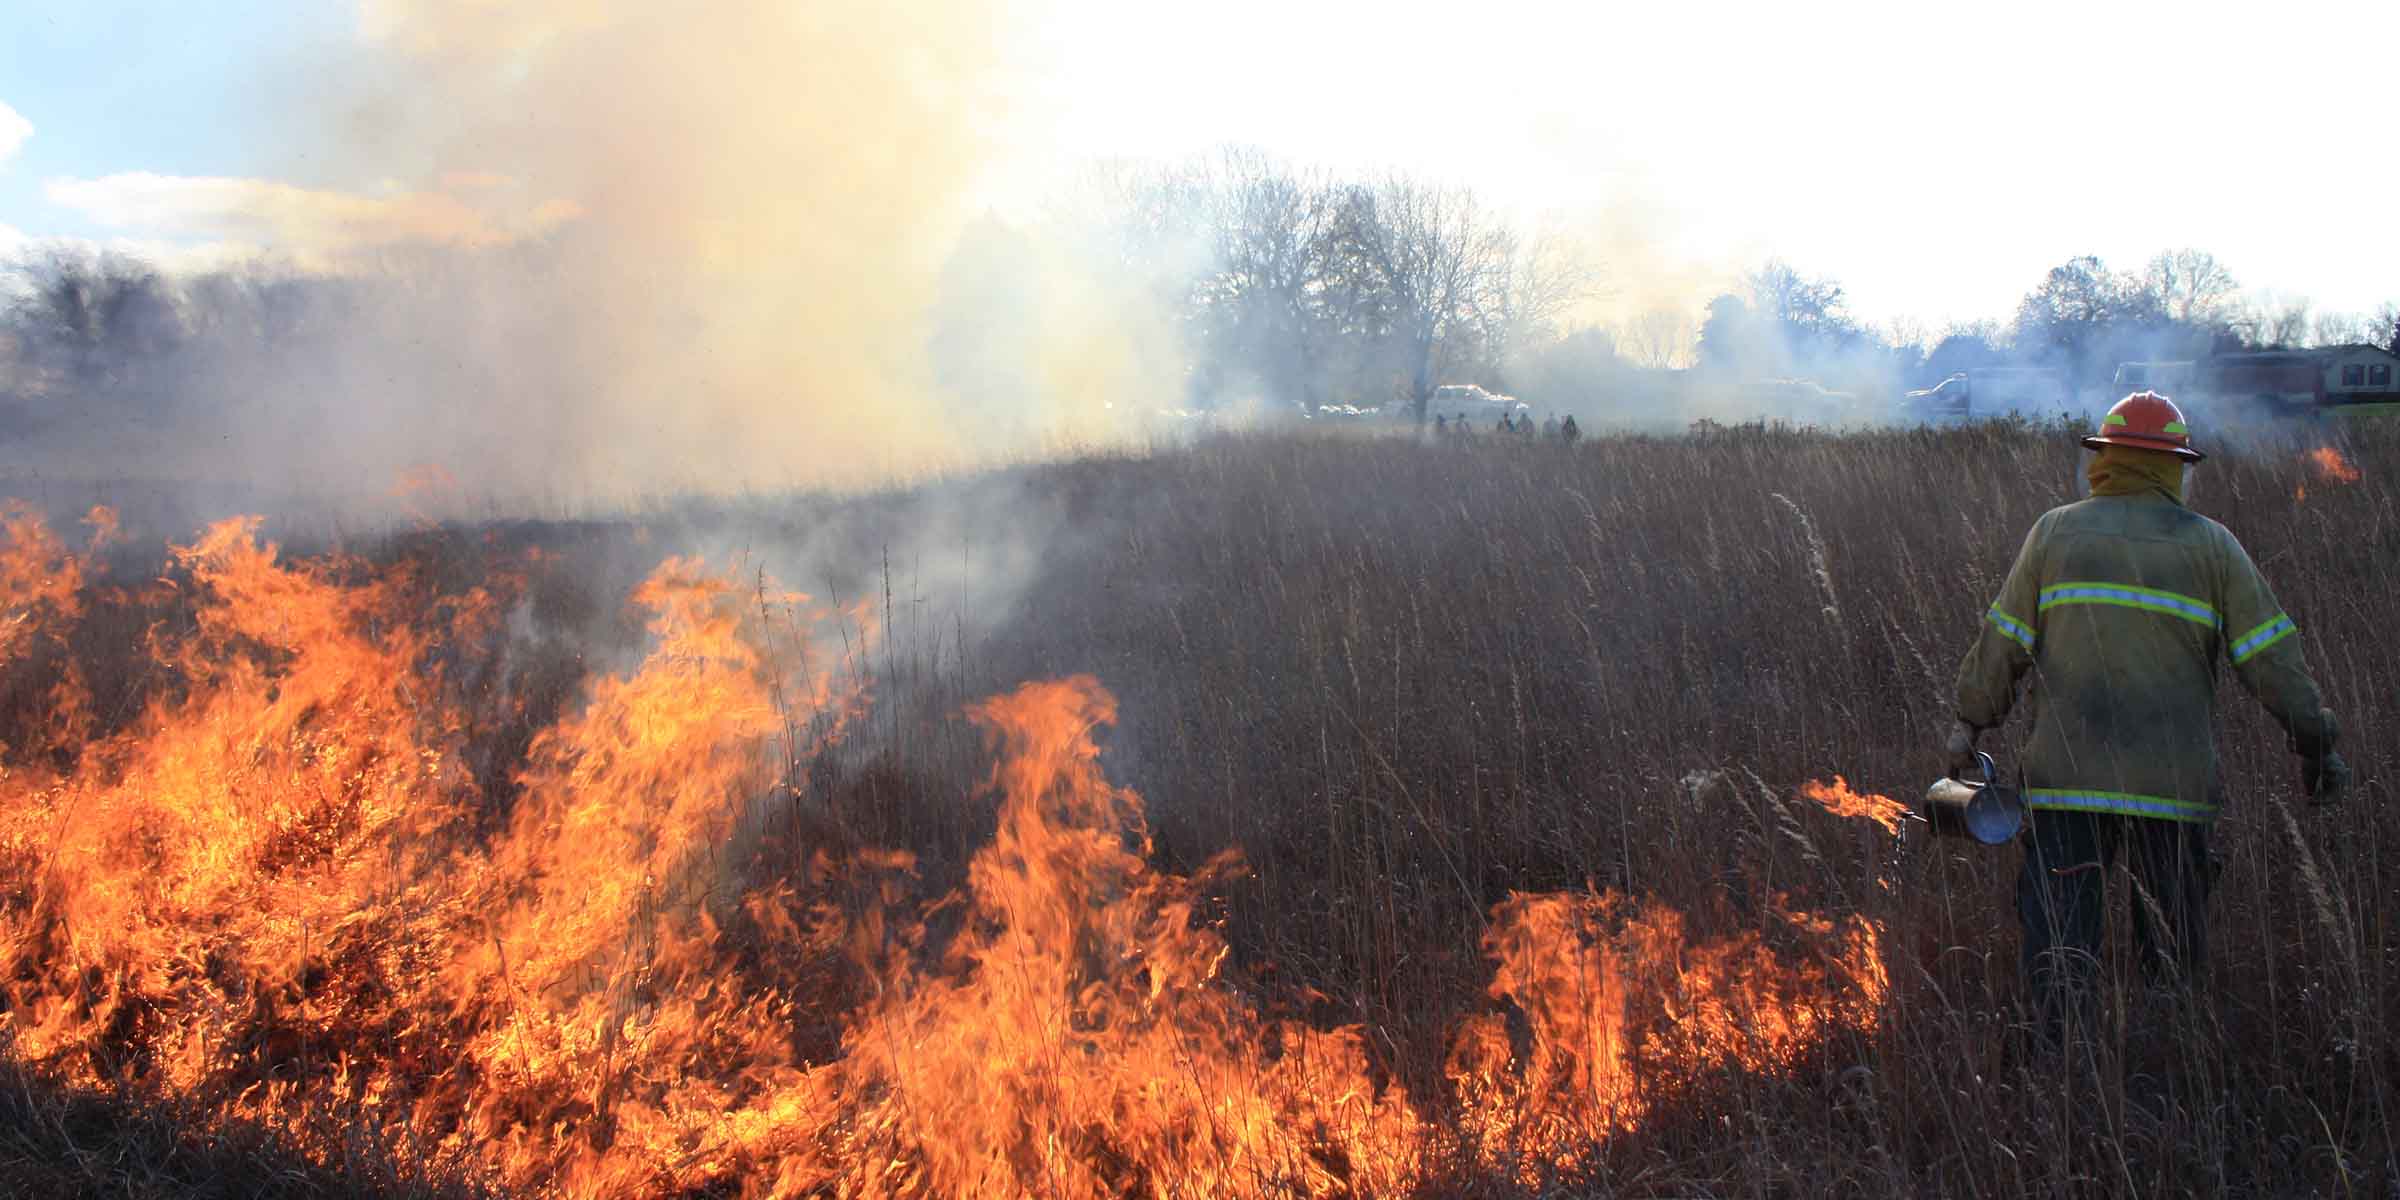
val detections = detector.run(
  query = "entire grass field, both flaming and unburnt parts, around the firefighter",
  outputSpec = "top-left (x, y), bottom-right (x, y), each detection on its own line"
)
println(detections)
top-left (0, 417), bottom-right (2400, 1195)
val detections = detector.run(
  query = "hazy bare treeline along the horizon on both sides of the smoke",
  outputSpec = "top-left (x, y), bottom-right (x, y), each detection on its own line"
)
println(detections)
top-left (0, 151), bottom-right (2400, 439)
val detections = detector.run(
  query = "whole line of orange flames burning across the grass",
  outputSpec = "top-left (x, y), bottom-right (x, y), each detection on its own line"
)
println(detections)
top-left (0, 506), bottom-right (1889, 1198)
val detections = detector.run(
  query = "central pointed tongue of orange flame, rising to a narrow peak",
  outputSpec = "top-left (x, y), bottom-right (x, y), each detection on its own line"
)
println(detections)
top-left (780, 679), bottom-right (1423, 1198)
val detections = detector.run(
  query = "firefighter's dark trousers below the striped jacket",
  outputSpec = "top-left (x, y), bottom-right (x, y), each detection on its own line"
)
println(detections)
top-left (2016, 809), bottom-right (2210, 1039)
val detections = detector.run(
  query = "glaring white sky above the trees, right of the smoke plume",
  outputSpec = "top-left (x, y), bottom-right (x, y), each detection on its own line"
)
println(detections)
top-left (984, 0), bottom-right (2400, 326)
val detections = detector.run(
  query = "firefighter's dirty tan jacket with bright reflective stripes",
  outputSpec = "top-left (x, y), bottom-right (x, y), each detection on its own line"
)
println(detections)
top-left (1958, 492), bottom-right (2333, 823)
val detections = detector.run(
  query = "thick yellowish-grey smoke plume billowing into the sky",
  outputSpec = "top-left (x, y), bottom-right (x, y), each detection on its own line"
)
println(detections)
top-left (10, 0), bottom-right (1171, 506)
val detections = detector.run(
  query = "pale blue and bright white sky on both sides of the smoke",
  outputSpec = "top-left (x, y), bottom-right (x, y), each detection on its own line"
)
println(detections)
top-left (0, 0), bottom-right (2400, 326)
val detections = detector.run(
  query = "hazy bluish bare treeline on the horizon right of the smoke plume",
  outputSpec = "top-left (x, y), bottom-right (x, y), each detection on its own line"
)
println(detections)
top-left (979, 154), bottom-right (2400, 420)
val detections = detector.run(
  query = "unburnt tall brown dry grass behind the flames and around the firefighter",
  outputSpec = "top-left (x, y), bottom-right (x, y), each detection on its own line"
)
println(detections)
top-left (0, 417), bottom-right (2400, 1195)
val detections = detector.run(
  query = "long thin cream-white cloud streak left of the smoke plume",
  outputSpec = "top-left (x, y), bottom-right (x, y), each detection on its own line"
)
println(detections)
top-left (46, 170), bottom-right (578, 254)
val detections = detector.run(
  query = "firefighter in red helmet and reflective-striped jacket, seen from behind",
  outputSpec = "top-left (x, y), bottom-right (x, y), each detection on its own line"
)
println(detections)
top-left (1944, 391), bottom-right (2350, 1044)
